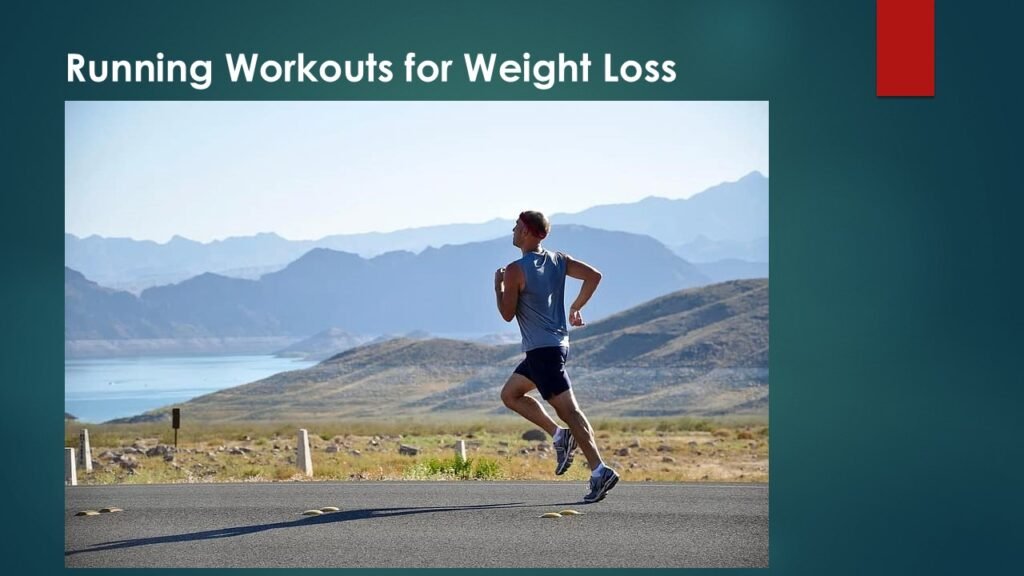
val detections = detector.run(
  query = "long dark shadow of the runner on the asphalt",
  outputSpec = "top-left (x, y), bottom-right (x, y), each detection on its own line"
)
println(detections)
top-left (65, 500), bottom-right (580, 557)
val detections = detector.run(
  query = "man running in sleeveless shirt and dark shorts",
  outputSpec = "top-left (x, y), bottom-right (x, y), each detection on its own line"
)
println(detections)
top-left (495, 211), bottom-right (618, 503)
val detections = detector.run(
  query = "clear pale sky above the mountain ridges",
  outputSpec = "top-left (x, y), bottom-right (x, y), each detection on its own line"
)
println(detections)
top-left (65, 101), bottom-right (769, 242)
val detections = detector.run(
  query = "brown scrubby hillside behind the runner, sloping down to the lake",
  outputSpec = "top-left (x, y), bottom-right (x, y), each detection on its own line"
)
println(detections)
top-left (119, 280), bottom-right (768, 421)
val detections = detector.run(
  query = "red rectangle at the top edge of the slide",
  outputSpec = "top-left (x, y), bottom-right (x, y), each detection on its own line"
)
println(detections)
top-left (876, 0), bottom-right (935, 96)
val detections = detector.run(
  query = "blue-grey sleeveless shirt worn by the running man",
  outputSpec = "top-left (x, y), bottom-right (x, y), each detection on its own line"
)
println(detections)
top-left (515, 250), bottom-right (569, 352)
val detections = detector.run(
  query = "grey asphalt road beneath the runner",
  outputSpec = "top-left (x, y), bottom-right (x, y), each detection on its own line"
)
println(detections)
top-left (65, 482), bottom-right (768, 568)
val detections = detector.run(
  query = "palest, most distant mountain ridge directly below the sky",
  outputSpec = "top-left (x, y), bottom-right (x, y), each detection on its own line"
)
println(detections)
top-left (65, 172), bottom-right (768, 292)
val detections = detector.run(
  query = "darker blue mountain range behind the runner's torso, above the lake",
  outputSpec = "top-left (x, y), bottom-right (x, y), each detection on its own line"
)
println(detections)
top-left (66, 225), bottom-right (709, 339)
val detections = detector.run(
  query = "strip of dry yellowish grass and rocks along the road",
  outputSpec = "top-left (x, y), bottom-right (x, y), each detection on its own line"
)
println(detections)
top-left (66, 418), bottom-right (768, 484)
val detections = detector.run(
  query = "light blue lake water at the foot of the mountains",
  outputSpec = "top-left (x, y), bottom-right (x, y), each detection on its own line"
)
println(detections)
top-left (65, 356), bottom-right (316, 422)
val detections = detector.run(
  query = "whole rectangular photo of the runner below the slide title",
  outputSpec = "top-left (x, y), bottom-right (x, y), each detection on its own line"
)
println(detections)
top-left (63, 100), bottom-right (770, 569)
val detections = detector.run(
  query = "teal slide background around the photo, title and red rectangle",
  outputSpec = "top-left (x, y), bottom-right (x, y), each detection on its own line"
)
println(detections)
top-left (0, 0), bottom-right (1024, 574)
